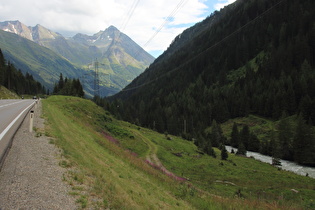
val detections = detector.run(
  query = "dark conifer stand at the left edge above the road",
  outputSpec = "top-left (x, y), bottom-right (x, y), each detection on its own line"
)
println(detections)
top-left (0, 49), bottom-right (46, 95)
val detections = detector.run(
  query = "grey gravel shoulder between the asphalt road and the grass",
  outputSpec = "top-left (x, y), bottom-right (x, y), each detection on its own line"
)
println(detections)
top-left (0, 103), bottom-right (78, 210)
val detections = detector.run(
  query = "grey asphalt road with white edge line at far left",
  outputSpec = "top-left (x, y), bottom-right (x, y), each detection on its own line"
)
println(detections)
top-left (0, 100), bottom-right (35, 163)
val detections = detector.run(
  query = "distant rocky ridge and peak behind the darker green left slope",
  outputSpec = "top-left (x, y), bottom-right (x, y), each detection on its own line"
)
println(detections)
top-left (0, 21), bottom-right (154, 96)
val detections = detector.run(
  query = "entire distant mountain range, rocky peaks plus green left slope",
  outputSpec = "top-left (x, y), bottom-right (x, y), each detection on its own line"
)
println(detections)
top-left (0, 21), bottom-right (154, 98)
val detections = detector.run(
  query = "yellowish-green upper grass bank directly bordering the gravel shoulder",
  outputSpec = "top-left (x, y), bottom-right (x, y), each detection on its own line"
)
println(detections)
top-left (44, 97), bottom-right (196, 209)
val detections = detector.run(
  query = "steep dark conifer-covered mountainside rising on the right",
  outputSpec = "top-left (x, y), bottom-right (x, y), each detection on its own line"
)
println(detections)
top-left (101, 0), bottom-right (315, 165)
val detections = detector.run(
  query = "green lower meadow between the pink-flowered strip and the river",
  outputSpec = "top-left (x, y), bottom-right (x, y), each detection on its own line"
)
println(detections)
top-left (127, 123), bottom-right (315, 207)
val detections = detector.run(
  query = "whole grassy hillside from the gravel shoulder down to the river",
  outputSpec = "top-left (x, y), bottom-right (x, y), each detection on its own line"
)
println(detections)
top-left (43, 96), bottom-right (315, 209)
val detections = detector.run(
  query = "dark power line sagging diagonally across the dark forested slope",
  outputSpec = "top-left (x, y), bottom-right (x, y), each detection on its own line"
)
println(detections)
top-left (121, 0), bottom-right (286, 92)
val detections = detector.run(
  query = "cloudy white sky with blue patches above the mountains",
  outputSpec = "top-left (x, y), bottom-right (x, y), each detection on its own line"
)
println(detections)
top-left (0, 0), bottom-right (235, 57)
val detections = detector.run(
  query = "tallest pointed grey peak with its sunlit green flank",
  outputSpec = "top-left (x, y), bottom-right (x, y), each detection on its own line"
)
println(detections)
top-left (68, 26), bottom-right (154, 89)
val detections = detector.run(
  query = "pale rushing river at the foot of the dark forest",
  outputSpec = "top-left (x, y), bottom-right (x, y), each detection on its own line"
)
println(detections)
top-left (225, 146), bottom-right (315, 179)
